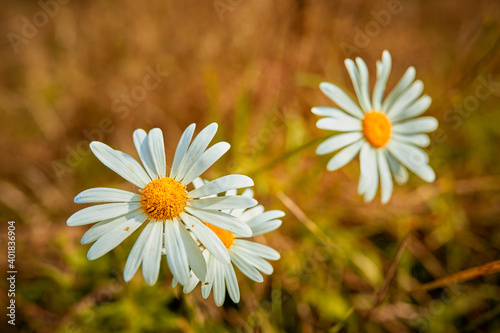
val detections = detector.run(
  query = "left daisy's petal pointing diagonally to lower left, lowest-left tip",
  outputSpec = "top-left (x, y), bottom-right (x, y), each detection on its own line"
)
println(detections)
top-left (87, 212), bottom-right (146, 260)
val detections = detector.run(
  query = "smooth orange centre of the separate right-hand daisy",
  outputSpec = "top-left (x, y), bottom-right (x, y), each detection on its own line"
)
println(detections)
top-left (363, 111), bottom-right (392, 148)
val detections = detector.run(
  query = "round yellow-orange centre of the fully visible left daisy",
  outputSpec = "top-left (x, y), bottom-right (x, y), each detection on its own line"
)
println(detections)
top-left (141, 177), bottom-right (187, 220)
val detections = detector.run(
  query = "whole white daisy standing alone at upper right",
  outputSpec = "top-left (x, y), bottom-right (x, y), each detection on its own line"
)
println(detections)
top-left (312, 51), bottom-right (438, 203)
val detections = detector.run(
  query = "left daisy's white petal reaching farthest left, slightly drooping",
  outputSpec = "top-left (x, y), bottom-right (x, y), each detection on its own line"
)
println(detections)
top-left (66, 202), bottom-right (141, 227)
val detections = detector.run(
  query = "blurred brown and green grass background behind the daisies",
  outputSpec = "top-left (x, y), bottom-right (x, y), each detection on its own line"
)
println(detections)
top-left (0, 0), bottom-right (500, 333)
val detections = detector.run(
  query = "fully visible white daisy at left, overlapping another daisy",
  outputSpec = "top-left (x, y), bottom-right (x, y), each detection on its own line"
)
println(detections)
top-left (67, 123), bottom-right (257, 285)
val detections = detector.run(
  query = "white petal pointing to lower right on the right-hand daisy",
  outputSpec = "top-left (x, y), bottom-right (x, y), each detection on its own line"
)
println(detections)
top-left (387, 140), bottom-right (436, 183)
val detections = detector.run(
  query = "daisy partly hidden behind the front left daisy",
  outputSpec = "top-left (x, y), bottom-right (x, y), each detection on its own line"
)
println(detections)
top-left (172, 179), bottom-right (285, 306)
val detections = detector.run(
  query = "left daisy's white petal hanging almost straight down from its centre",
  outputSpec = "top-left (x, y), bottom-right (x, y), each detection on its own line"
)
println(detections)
top-left (142, 221), bottom-right (163, 286)
